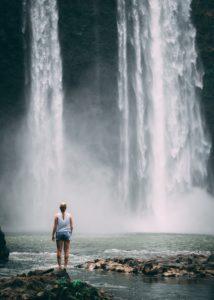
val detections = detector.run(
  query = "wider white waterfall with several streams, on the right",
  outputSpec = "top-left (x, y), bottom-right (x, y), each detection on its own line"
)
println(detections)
top-left (117, 0), bottom-right (211, 212)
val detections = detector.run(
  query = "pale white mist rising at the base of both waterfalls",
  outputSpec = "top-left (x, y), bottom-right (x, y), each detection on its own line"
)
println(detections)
top-left (1, 97), bottom-right (214, 234)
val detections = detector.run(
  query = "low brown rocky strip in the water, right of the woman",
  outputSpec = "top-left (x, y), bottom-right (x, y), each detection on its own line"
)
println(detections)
top-left (77, 254), bottom-right (214, 279)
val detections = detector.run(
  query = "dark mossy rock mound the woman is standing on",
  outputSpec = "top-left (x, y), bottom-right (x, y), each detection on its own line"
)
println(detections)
top-left (0, 269), bottom-right (112, 300)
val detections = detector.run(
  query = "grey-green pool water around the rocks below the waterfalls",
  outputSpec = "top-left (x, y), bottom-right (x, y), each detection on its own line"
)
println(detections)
top-left (0, 233), bottom-right (214, 300)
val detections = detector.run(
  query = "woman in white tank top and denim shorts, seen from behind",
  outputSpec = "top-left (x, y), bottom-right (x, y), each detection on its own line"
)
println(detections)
top-left (52, 203), bottom-right (73, 269)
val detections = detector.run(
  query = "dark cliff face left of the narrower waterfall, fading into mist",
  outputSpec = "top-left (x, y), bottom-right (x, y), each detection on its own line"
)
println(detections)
top-left (0, 0), bottom-right (25, 183)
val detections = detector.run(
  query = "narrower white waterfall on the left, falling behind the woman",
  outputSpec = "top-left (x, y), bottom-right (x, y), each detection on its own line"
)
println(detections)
top-left (27, 0), bottom-right (63, 216)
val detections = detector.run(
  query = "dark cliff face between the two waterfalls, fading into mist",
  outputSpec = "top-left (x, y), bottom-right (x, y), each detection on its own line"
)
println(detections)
top-left (58, 0), bottom-right (119, 165)
